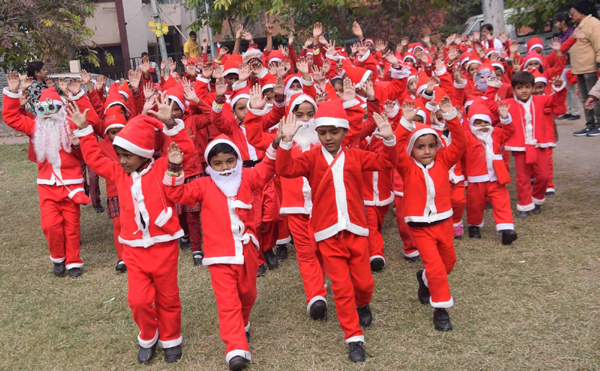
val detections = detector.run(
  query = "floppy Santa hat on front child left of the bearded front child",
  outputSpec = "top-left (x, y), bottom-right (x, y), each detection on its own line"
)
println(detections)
top-left (113, 115), bottom-right (164, 158)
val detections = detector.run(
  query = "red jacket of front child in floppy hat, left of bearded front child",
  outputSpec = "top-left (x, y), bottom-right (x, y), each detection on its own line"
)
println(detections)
top-left (75, 120), bottom-right (195, 248)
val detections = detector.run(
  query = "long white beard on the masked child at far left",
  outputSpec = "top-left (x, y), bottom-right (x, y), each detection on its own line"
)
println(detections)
top-left (33, 107), bottom-right (71, 165)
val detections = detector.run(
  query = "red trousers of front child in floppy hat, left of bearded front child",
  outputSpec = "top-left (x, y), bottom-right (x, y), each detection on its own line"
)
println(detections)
top-left (123, 240), bottom-right (182, 348)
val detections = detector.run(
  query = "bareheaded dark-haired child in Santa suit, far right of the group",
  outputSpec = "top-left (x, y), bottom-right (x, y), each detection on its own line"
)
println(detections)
top-left (486, 71), bottom-right (567, 219)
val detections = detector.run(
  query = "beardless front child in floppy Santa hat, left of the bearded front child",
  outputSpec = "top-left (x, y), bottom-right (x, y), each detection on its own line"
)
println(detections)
top-left (72, 99), bottom-right (197, 363)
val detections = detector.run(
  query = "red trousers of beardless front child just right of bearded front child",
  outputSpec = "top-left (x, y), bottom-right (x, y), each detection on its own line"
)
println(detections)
top-left (317, 231), bottom-right (375, 344)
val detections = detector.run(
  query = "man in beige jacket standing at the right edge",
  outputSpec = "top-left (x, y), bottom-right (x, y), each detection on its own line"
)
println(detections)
top-left (570, 0), bottom-right (600, 137)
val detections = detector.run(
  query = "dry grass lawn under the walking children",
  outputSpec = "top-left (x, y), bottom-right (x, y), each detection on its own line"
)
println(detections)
top-left (0, 120), bottom-right (600, 371)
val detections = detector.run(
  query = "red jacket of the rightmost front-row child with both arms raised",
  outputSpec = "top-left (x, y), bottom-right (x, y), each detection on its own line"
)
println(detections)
top-left (396, 110), bottom-right (466, 223)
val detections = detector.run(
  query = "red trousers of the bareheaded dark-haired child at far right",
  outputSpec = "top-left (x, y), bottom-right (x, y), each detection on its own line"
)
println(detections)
top-left (513, 148), bottom-right (550, 211)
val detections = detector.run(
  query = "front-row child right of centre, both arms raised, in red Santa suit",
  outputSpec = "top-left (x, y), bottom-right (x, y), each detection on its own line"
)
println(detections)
top-left (396, 97), bottom-right (466, 331)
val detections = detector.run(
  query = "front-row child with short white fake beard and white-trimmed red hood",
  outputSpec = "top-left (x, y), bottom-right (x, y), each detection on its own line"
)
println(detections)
top-left (164, 135), bottom-right (279, 370)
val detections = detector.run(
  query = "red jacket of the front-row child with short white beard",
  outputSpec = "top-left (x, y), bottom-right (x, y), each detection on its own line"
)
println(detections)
top-left (164, 147), bottom-right (276, 265)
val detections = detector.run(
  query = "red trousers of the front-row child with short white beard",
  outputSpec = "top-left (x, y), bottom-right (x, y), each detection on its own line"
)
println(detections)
top-left (208, 242), bottom-right (258, 362)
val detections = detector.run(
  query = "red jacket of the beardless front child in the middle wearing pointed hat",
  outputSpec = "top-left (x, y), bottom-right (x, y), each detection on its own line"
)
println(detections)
top-left (277, 139), bottom-right (397, 241)
